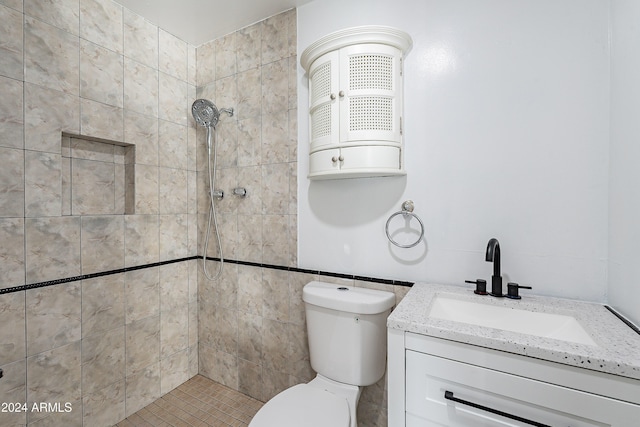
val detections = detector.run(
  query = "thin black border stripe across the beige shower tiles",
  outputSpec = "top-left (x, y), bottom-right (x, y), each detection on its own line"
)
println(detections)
top-left (0, 255), bottom-right (416, 296)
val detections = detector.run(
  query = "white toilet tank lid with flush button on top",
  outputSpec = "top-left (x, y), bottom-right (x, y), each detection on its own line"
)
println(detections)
top-left (302, 281), bottom-right (396, 314)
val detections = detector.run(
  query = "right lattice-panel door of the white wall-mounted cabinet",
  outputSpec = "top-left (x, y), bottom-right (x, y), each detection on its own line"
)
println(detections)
top-left (338, 44), bottom-right (402, 144)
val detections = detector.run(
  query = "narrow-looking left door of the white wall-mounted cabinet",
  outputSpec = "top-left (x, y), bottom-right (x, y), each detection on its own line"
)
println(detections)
top-left (309, 51), bottom-right (340, 153)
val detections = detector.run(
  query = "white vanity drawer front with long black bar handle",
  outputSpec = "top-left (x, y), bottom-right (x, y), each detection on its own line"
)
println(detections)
top-left (406, 350), bottom-right (640, 427)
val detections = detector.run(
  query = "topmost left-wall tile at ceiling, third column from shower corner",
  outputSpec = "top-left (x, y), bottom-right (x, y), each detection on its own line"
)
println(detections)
top-left (80, 0), bottom-right (124, 54)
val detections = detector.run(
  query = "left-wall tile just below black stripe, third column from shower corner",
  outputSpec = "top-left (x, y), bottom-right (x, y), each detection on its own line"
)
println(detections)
top-left (82, 273), bottom-right (125, 338)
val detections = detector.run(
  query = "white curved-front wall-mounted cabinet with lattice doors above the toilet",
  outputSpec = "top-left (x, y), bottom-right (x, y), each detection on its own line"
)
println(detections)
top-left (300, 26), bottom-right (411, 179)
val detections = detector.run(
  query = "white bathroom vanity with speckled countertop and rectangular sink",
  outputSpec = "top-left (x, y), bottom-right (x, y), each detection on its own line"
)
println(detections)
top-left (387, 284), bottom-right (640, 427)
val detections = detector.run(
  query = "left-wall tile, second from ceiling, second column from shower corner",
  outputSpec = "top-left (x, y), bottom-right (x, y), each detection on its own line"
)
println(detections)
top-left (124, 58), bottom-right (159, 117)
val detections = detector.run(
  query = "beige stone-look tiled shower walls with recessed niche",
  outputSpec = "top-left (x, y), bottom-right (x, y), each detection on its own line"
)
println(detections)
top-left (0, 0), bottom-right (408, 427)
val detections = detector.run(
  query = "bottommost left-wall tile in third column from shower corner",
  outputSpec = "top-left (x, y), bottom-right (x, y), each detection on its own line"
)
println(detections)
top-left (82, 379), bottom-right (125, 426)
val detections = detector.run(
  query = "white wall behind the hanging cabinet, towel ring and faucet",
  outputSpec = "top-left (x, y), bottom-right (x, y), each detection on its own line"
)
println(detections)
top-left (298, 0), bottom-right (609, 301)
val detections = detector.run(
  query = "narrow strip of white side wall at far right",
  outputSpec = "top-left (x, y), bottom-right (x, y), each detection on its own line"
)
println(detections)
top-left (609, 0), bottom-right (640, 324)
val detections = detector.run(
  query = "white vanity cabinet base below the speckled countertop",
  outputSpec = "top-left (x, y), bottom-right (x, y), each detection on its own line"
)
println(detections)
top-left (388, 329), bottom-right (640, 427)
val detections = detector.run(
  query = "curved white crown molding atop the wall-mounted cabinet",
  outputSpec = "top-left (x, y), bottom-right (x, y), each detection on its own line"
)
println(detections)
top-left (300, 25), bottom-right (413, 71)
